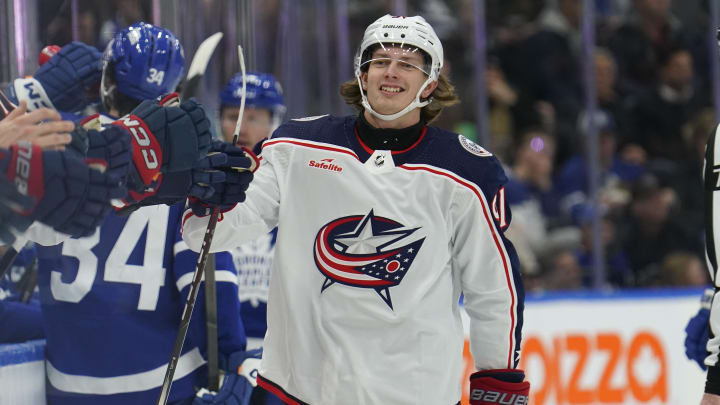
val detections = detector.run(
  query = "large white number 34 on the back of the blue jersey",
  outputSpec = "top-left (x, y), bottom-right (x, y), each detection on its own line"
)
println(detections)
top-left (50, 205), bottom-right (170, 311)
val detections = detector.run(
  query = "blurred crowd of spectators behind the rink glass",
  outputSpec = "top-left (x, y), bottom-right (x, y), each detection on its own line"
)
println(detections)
top-left (0, 0), bottom-right (718, 292)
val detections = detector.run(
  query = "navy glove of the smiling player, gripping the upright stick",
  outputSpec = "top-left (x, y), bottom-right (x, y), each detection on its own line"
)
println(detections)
top-left (188, 142), bottom-right (260, 217)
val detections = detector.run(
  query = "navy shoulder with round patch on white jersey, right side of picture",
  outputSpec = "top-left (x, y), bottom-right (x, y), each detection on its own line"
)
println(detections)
top-left (418, 127), bottom-right (508, 198)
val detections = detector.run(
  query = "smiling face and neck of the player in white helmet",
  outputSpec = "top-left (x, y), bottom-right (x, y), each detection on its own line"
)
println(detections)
top-left (360, 47), bottom-right (437, 128)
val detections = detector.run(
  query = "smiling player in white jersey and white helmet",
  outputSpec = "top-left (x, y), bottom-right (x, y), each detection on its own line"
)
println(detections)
top-left (183, 15), bottom-right (529, 405)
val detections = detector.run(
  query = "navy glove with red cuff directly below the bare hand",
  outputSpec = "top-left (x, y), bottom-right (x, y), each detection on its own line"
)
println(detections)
top-left (0, 142), bottom-right (127, 237)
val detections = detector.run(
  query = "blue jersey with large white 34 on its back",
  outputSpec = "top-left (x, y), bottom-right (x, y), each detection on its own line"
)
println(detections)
top-left (37, 204), bottom-right (245, 405)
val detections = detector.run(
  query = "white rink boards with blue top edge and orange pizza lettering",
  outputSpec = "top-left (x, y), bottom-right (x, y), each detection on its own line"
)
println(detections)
top-left (0, 289), bottom-right (704, 405)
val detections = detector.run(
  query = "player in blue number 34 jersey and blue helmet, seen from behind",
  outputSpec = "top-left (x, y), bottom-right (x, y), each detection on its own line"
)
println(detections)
top-left (25, 23), bottom-right (255, 405)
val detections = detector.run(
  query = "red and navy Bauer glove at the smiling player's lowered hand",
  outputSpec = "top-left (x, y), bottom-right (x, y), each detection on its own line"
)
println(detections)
top-left (470, 369), bottom-right (530, 405)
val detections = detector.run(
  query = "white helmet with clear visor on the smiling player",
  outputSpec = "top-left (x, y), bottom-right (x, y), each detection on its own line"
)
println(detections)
top-left (355, 14), bottom-right (443, 121)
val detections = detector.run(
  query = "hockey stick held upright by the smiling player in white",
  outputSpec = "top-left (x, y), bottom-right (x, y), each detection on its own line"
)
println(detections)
top-left (158, 46), bottom-right (246, 405)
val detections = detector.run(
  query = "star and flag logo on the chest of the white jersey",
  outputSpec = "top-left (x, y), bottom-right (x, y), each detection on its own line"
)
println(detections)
top-left (314, 210), bottom-right (425, 309)
